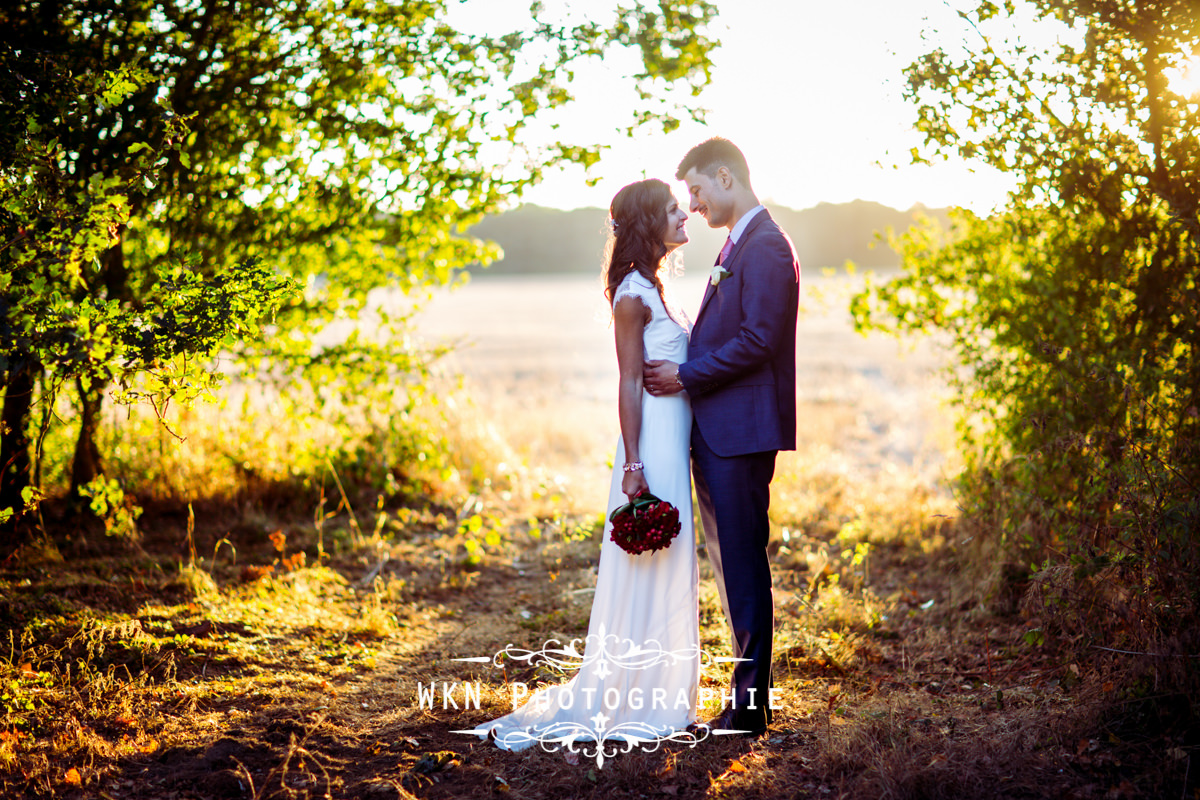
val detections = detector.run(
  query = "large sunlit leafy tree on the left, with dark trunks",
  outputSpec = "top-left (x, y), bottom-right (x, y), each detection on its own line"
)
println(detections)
top-left (0, 0), bottom-right (715, 510)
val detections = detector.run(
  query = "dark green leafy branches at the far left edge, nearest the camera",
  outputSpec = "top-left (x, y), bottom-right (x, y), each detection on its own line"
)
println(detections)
top-left (0, 46), bottom-right (290, 515)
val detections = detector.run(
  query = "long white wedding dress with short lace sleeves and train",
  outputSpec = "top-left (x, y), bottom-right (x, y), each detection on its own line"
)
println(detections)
top-left (472, 272), bottom-right (701, 758)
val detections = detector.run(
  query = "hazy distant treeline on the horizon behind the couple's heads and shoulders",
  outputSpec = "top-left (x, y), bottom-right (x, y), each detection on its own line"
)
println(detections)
top-left (469, 200), bottom-right (948, 275)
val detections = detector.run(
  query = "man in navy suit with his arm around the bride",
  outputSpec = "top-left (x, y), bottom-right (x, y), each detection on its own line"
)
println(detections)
top-left (643, 138), bottom-right (800, 735)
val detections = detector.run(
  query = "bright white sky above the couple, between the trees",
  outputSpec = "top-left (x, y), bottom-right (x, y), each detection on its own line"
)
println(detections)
top-left (453, 0), bottom-right (1008, 211)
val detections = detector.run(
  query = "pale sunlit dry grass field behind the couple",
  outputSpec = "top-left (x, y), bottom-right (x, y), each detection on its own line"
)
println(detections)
top-left (419, 272), bottom-right (952, 510)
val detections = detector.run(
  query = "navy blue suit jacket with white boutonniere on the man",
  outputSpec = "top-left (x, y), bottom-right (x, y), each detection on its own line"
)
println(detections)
top-left (679, 209), bottom-right (800, 457)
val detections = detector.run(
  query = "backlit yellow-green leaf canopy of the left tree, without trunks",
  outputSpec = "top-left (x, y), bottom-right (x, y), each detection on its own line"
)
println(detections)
top-left (7, 0), bottom-right (713, 289)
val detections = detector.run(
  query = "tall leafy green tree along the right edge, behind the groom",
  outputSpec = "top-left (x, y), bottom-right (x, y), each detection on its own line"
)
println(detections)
top-left (854, 0), bottom-right (1200, 648)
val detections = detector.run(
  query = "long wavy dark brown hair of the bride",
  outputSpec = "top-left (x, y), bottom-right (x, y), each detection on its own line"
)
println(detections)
top-left (604, 178), bottom-right (672, 306)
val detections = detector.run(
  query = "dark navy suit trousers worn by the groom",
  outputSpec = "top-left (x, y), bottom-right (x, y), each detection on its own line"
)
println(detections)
top-left (691, 420), bottom-right (776, 729)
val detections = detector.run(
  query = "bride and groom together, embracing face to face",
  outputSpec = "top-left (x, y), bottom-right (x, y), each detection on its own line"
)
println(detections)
top-left (474, 138), bottom-right (800, 750)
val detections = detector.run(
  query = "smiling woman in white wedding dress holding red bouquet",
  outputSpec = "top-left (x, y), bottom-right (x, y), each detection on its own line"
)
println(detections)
top-left (473, 179), bottom-right (701, 750)
